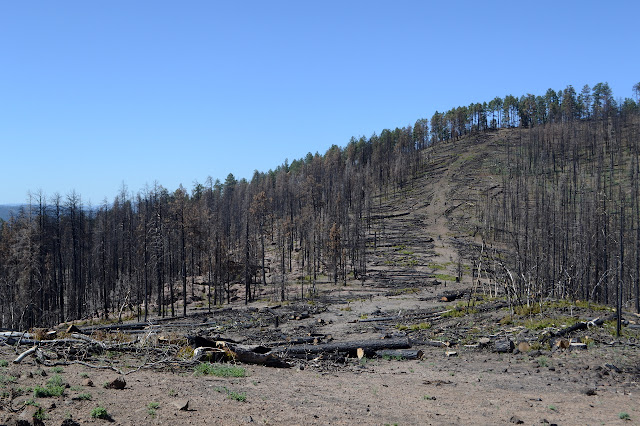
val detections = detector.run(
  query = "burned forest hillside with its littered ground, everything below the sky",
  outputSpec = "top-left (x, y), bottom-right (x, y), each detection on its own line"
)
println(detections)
top-left (0, 83), bottom-right (640, 424)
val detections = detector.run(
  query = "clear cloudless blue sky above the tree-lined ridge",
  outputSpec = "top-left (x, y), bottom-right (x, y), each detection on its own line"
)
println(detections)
top-left (0, 0), bottom-right (640, 205)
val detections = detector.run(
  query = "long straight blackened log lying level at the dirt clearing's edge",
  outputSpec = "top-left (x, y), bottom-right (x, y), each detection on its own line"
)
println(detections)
top-left (273, 337), bottom-right (411, 357)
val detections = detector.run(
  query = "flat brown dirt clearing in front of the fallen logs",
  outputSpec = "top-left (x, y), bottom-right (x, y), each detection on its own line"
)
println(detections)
top-left (2, 342), bottom-right (640, 425)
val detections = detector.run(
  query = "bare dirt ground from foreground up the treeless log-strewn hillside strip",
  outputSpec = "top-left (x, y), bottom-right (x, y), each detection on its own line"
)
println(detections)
top-left (0, 135), bottom-right (640, 425)
